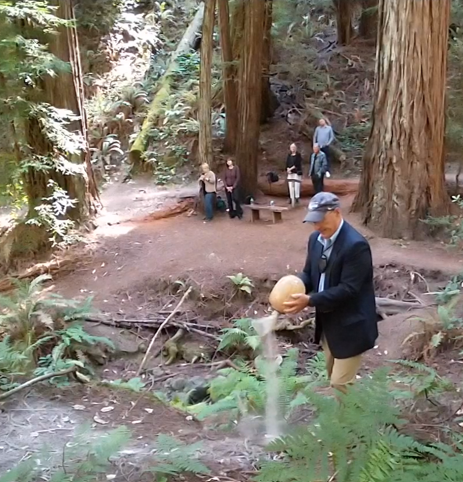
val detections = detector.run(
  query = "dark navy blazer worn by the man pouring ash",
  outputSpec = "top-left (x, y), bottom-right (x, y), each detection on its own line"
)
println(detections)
top-left (299, 221), bottom-right (378, 359)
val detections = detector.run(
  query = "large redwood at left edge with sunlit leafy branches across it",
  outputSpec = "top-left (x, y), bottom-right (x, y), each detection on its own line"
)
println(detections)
top-left (0, 0), bottom-right (98, 266)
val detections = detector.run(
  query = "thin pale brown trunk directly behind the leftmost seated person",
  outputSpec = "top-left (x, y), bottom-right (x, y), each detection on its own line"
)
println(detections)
top-left (198, 0), bottom-right (215, 165)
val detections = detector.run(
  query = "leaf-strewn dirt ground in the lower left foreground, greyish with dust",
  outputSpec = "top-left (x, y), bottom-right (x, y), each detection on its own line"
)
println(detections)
top-left (0, 385), bottom-right (263, 476)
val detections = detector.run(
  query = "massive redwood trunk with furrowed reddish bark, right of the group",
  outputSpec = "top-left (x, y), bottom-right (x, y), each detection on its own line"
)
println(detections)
top-left (354, 0), bottom-right (450, 238)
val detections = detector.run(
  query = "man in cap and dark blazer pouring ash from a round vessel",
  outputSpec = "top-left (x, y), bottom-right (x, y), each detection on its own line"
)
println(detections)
top-left (285, 192), bottom-right (378, 392)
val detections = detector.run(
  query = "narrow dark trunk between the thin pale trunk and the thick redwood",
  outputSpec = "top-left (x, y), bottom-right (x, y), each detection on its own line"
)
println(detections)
top-left (218, 0), bottom-right (238, 153)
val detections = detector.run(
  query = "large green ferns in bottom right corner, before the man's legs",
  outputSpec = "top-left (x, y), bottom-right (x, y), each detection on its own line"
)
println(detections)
top-left (255, 371), bottom-right (463, 482)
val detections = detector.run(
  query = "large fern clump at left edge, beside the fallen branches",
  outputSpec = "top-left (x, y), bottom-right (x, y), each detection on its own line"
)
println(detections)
top-left (0, 275), bottom-right (114, 388)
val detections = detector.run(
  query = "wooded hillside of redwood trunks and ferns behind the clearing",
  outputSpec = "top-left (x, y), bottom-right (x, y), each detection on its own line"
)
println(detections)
top-left (1, 0), bottom-right (463, 267)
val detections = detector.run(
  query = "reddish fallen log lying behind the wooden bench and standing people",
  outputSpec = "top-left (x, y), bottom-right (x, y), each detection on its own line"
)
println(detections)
top-left (257, 175), bottom-right (463, 197)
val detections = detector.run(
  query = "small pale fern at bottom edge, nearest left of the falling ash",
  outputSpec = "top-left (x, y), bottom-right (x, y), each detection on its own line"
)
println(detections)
top-left (150, 434), bottom-right (210, 482)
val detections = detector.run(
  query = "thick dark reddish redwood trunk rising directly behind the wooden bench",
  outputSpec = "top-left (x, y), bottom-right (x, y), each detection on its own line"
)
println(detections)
top-left (236, 0), bottom-right (265, 195)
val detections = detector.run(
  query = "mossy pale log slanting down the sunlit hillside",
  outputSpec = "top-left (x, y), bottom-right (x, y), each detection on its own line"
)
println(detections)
top-left (129, 2), bottom-right (204, 164)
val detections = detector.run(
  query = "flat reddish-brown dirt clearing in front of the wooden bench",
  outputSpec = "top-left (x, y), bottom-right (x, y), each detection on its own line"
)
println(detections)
top-left (58, 188), bottom-right (463, 311)
